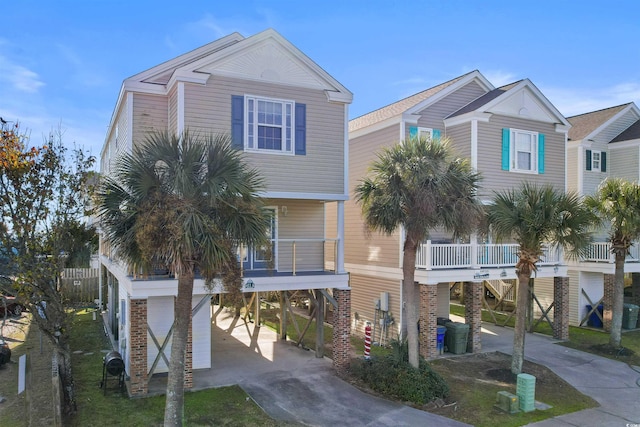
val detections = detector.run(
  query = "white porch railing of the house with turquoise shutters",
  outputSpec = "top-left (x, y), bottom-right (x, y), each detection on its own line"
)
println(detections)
top-left (416, 240), bottom-right (562, 270)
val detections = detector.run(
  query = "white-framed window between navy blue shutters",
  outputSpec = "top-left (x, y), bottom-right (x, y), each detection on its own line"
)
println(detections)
top-left (245, 96), bottom-right (295, 154)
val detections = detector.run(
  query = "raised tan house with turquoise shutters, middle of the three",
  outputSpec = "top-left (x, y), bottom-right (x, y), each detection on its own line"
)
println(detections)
top-left (345, 71), bottom-right (570, 357)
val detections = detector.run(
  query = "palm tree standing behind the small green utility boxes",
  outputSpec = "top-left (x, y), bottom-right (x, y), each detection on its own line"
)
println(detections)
top-left (487, 182), bottom-right (593, 374)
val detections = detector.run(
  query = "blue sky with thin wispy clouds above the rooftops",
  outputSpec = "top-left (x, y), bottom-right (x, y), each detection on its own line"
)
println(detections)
top-left (0, 0), bottom-right (640, 159)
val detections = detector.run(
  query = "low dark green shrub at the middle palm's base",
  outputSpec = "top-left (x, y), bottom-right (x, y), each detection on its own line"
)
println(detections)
top-left (351, 341), bottom-right (449, 405)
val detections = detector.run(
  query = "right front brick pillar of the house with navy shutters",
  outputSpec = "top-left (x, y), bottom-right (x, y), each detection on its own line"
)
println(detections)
top-left (333, 289), bottom-right (351, 372)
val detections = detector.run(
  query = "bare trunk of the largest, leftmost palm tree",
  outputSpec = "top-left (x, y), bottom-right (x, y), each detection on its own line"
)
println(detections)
top-left (164, 268), bottom-right (194, 427)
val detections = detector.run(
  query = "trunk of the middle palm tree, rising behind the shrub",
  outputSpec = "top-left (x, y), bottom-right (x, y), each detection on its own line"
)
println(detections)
top-left (402, 236), bottom-right (420, 368)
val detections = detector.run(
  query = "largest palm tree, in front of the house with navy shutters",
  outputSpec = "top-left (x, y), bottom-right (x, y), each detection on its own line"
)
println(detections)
top-left (97, 132), bottom-right (269, 426)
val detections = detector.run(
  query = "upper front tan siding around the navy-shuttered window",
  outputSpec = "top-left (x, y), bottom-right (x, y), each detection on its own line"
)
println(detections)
top-left (185, 76), bottom-right (345, 194)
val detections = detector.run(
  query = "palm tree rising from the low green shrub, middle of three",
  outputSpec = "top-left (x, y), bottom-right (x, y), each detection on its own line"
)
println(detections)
top-left (355, 138), bottom-right (481, 367)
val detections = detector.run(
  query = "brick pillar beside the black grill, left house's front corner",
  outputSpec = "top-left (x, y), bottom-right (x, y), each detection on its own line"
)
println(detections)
top-left (129, 299), bottom-right (148, 396)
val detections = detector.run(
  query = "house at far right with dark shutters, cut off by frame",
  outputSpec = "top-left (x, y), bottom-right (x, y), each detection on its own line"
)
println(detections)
top-left (567, 102), bottom-right (640, 330)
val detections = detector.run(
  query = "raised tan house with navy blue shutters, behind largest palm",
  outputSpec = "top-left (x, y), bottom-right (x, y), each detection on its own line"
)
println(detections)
top-left (100, 29), bottom-right (352, 395)
